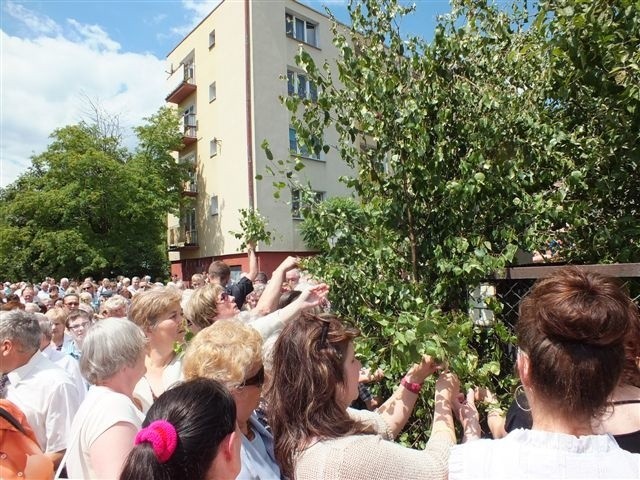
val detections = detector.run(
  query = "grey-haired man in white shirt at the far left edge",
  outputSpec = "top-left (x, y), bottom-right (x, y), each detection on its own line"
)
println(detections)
top-left (0, 309), bottom-right (80, 465)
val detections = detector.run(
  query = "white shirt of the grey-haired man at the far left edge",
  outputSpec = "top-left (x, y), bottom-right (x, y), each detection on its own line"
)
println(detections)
top-left (6, 351), bottom-right (80, 453)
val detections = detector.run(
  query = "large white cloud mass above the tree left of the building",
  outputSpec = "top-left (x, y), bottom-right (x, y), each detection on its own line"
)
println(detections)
top-left (0, 9), bottom-right (167, 187)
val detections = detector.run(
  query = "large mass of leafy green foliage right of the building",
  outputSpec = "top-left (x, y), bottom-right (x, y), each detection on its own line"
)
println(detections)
top-left (265, 0), bottom-right (640, 443)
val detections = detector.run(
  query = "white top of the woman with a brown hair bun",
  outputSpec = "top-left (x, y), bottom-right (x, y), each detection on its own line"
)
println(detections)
top-left (449, 429), bottom-right (640, 480)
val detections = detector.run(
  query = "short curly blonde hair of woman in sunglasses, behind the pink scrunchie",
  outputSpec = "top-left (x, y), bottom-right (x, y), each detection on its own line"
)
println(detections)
top-left (182, 320), bottom-right (262, 390)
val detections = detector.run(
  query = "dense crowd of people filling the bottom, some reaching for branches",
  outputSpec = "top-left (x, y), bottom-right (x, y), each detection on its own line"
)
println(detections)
top-left (0, 258), bottom-right (640, 480)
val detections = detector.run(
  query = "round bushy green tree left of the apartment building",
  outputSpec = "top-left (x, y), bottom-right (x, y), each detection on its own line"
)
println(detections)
top-left (0, 108), bottom-right (186, 280)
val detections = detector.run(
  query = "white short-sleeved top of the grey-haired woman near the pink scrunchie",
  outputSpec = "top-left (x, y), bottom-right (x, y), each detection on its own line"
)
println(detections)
top-left (66, 385), bottom-right (144, 478)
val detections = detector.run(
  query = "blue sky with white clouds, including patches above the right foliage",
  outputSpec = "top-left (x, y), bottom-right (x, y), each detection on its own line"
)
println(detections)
top-left (0, 0), bottom-right (449, 187)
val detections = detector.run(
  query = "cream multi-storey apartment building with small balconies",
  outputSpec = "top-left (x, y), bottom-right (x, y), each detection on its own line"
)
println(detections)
top-left (166, 0), bottom-right (349, 280)
